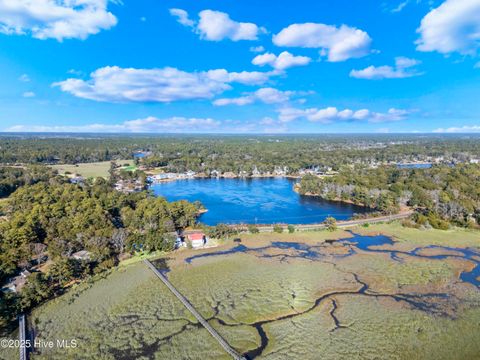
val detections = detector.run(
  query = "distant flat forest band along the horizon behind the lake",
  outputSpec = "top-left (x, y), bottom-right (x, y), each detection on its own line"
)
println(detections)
top-left (0, 134), bottom-right (480, 173)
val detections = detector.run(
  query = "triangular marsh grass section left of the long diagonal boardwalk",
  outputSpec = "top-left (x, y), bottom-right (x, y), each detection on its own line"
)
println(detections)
top-left (32, 263), bottom-right (227, 359)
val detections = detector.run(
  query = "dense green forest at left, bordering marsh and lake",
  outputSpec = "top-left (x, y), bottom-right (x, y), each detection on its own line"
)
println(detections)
top-left (0, 177), bottom-right (198, 327)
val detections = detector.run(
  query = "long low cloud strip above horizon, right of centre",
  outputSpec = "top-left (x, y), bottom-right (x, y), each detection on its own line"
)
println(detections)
top-left (278, 107), bottom-right (410, 124)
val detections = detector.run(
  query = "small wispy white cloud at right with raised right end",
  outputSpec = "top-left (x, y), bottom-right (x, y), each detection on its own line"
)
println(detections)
top-left (350, 57), bottom-right (422, 80)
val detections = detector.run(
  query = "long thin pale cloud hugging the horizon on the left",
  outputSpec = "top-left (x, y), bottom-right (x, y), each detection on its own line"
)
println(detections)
top-left (5, 116), bottom-right (221, 133)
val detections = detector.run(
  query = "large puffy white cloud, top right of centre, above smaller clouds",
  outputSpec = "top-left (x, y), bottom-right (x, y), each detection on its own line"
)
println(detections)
top-left (273, 23), bottom-right (372, 62)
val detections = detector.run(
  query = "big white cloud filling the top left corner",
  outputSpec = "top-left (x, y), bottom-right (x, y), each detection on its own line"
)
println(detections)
top-left (0, 0), bottom-right (117, 41)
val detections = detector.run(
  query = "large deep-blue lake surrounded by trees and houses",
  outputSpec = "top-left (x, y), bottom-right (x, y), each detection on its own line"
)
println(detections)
top-left (151, 178), bottom-right (365, 225)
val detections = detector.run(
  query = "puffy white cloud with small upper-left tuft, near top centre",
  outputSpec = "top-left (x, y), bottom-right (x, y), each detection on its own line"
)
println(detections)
top-left (170, 9), bottom-right (266, 41)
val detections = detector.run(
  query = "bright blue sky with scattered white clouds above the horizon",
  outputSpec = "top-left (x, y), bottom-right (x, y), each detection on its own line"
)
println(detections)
top-left (0, 0), bottom-right (480, 133)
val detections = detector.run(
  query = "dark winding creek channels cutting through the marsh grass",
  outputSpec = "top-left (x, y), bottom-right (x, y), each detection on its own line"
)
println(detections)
top-left (156, 233), bottom-right (480, 359)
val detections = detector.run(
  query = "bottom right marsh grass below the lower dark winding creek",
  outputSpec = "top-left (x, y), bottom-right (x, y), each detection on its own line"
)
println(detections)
top-left (263, 295), bottom-right (480, 360)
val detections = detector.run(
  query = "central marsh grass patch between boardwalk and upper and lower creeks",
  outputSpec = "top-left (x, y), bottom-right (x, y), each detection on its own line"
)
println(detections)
top-left (169, 254), bottom-right (358, 324)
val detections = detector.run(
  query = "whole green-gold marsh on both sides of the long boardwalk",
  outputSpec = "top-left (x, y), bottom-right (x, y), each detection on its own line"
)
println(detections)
top-left (27, 224), bottom-right (480, 360)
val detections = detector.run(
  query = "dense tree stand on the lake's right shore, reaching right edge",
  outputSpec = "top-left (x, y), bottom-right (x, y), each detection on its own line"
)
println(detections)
top-left (298, 164), bottom-right (480, 228)
